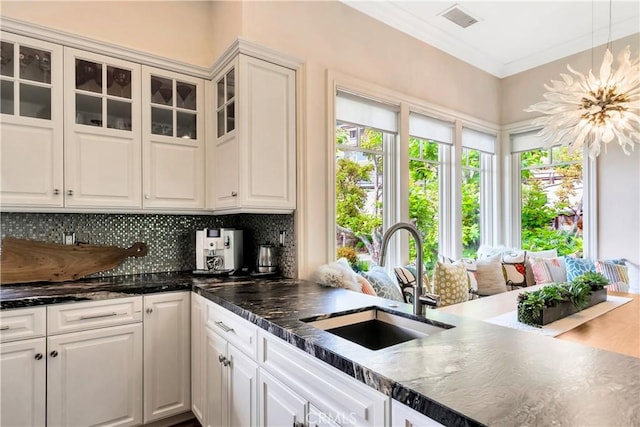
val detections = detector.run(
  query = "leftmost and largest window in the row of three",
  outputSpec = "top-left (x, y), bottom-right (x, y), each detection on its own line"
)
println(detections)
top-left (335, 92), bottom-right (397, 269)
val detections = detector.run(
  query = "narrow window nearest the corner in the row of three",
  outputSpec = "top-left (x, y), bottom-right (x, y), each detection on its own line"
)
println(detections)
top-left (461, 127), bottom-right (496, 258)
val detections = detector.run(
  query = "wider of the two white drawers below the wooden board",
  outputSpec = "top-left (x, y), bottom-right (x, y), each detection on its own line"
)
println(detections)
top-left (47, 296), bottom-right (142, 335)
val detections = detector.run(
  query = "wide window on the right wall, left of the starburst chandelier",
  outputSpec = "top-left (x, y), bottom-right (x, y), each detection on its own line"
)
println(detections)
top-left (512, 133), bottom-right (583, 255)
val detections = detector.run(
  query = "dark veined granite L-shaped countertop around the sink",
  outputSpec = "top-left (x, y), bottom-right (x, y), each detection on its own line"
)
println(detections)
top-left (0, 273), bottom-right (640, 426)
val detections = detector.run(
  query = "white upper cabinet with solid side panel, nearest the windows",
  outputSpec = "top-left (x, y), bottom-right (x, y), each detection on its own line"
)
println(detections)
top-left (207, 54), bottom-right (296, 213)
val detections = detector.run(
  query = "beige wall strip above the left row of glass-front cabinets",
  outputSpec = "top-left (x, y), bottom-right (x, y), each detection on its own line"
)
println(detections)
top-left (0, 0), bottom-right (218, 67)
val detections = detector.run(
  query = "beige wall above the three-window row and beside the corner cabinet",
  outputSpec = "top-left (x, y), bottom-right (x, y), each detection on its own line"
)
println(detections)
top-left (242, 1), bottom-right (500, 277)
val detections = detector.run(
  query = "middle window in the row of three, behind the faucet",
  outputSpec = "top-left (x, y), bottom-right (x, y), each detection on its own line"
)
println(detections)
top-left (409, 112), bottom-right (453, 270)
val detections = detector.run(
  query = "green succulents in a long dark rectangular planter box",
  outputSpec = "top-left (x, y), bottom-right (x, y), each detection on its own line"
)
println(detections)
top-left (518, 272), bottom-right (608, 327)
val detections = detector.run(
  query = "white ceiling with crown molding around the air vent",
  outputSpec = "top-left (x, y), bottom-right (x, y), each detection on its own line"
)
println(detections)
top-left (342, 0), bottom-right (640, 77)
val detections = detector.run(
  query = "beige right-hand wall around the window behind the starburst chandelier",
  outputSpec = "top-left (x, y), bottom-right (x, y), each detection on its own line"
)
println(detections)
top-left (500, 33), bottom-right (640, 263)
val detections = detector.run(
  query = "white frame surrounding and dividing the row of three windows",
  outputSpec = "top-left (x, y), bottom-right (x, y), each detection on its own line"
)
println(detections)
top-left (326, 70), bottom-right (501, 266)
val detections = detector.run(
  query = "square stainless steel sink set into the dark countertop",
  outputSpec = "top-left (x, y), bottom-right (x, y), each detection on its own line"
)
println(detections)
top-left (301, 307), bottom-right (453, 350)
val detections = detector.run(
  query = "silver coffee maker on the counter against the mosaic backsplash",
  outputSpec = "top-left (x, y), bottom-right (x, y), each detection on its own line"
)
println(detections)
top-left (194, 228), bottom-right (242, 274)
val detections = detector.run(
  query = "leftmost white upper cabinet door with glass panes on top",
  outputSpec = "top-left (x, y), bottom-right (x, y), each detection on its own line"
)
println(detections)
top-left (0, 32), bottom-right (64, 207)
